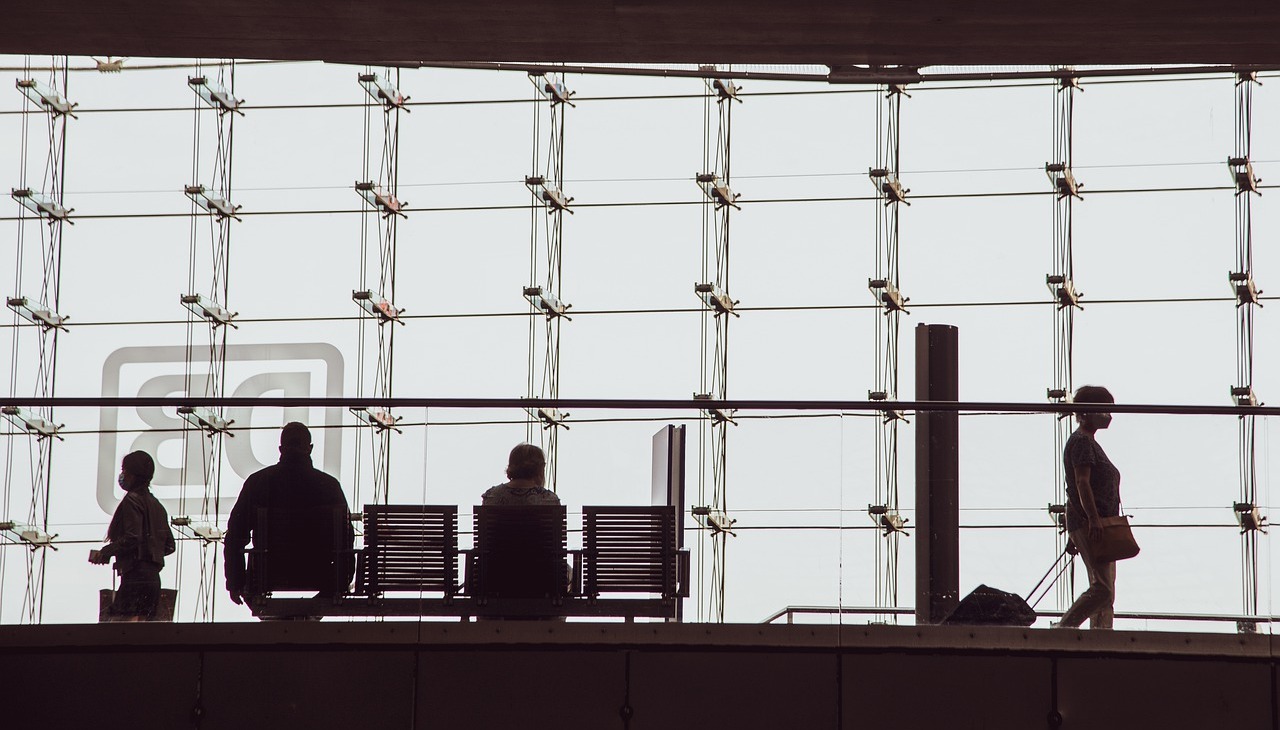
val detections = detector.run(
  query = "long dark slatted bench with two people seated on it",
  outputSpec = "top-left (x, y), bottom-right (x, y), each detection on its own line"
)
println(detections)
top-left (251, 505), bottom-right (689, 621)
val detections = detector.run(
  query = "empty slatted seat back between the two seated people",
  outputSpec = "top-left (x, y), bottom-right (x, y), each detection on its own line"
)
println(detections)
top-left (356, 505), bottom-right (458, 596)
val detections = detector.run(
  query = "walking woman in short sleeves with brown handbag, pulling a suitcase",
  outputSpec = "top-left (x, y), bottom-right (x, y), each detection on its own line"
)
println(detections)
top-left (1056, 385), bottom-right (1137, 629)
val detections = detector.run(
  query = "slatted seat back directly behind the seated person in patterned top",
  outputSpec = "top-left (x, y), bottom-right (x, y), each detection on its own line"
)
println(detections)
top-left (467, 505), bottom-right (568, 598)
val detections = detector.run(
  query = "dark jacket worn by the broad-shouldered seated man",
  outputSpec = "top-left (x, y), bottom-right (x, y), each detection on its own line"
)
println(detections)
top-left (223, 453), bottom-right (355, 594)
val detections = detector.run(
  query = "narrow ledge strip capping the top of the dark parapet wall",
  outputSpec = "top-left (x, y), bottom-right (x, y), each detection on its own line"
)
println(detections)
top-left (0, 621), bottom-right (1276, 661)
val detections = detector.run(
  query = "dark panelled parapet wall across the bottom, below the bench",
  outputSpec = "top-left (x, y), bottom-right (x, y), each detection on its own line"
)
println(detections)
top-left (0, 622), bottom-right (1280, 730)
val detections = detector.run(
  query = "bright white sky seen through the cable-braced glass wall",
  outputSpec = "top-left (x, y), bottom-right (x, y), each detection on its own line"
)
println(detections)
top-left (0, 56), bottom-right (1280, 628)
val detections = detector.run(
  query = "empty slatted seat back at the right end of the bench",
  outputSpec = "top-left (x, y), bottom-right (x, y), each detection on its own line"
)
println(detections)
top-left (582, 507), bottom-right (677, 598)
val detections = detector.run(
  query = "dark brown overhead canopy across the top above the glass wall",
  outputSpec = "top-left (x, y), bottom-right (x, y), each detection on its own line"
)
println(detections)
top-left (0, 0), bottom-right (1280, 65)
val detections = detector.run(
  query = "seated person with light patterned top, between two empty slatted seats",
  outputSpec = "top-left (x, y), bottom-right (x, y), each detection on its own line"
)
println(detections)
top-left (472, 443), bottom-right (570, 599)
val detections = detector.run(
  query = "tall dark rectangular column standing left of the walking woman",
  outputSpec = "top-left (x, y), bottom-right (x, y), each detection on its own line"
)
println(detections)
top-left (915, 324), bottom-right (960, 624)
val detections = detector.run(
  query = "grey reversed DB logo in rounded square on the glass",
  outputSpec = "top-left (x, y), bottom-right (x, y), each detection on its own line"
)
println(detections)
top-left (97, 343), bottom-right (343, 515)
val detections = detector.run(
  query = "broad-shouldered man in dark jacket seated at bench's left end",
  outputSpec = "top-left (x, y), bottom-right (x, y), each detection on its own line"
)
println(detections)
top-left (224, 421), bottom-right (355, 603)
